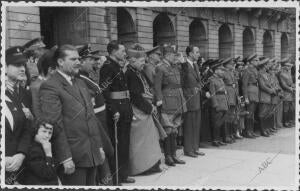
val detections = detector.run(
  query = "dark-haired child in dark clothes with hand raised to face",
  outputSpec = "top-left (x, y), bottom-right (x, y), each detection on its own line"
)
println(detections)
top-left (22, 123), bottom-right (58, 185)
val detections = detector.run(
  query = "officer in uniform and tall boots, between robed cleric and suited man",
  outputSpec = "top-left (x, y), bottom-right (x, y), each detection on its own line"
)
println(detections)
top-left (154, 45), bottom-right (186, 166)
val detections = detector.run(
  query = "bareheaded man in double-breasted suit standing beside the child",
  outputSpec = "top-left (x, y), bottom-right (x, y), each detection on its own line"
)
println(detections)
top-left (40, 45), bottom-right (105, 185)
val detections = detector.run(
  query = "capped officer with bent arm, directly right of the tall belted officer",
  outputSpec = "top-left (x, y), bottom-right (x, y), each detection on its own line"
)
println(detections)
top-left (257, 57), bottom-right (276, 137)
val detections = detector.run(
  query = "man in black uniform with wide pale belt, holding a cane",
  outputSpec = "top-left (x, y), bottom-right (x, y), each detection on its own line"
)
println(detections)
top-left (99, 41), bottom-right (135, 183)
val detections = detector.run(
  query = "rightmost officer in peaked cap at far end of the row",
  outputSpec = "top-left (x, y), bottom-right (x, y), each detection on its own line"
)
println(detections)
top-left (278, 59), bottom-right (295, 127)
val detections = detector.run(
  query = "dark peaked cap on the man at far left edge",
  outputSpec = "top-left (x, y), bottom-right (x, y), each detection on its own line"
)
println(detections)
top-left (5, 46), bottom-right (27, 66)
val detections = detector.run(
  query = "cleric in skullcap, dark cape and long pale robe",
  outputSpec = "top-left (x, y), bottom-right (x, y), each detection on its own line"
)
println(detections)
top-left (125, 44), bottom-right (161, 175)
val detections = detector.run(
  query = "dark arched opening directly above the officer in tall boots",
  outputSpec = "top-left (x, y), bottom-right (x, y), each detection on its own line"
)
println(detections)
top-left (153, 13), bottom-right (175, 46)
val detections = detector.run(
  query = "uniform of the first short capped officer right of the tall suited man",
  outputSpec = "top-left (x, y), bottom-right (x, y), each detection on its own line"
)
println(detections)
top-left (209, 71), bottom-right (228, 145)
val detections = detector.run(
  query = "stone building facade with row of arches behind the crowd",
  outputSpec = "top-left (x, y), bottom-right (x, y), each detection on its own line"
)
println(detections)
top-left (5, 7), bottom-right (296, 62)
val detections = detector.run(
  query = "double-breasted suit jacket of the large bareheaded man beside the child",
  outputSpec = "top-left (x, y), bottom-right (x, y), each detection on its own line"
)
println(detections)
top-left (40, 72), bottom-right (102, 167)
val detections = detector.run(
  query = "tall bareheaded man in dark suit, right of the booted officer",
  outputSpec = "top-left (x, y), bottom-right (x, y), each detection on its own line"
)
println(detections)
top-left (182, 46), bottom-right (204, 157)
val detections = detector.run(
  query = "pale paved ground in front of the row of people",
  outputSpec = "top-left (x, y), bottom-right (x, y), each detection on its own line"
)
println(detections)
top-left (124, 128), bottom-right (298, 189)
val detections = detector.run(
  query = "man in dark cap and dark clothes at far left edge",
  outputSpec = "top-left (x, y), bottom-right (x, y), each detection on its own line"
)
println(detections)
top-left (4, 46), bottom-right (33, 184)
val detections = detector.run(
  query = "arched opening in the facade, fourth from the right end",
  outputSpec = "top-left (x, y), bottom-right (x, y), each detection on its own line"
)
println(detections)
top-left (219, 24), bottom-right (233, 58)
